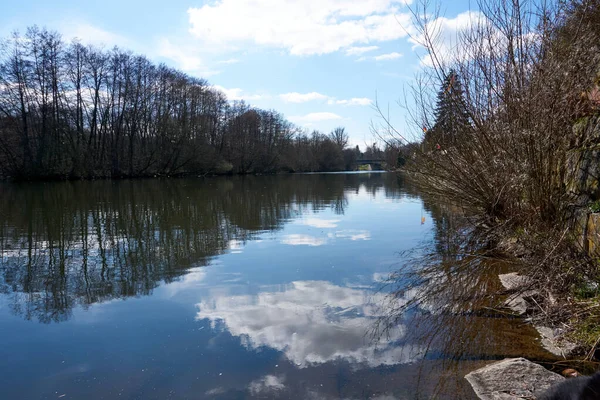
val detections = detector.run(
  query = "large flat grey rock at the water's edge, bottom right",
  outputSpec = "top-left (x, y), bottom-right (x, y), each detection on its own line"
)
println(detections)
top-left (465, 358), bottom-right (565, 400)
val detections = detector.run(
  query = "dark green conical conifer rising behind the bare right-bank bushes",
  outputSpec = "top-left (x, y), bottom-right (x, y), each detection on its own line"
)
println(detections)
top-left (425, 70), bottom-right (470, 146)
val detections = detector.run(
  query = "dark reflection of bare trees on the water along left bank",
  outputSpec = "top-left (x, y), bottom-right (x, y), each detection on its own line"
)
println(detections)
top-left (0, 174), bottom-right (401, 323)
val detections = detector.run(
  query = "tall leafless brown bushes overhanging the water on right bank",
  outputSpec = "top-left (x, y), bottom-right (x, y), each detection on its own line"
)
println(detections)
top-left (390, 0), bottom-right (600, 225)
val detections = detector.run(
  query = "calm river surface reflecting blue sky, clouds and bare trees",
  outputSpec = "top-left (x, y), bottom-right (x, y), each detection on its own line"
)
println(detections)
top-left (0, 173), bottom-right (547, 399)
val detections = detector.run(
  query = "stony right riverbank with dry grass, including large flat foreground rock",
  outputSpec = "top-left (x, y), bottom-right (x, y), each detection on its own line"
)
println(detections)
top-left (450, 225), bottom-right (600, 400)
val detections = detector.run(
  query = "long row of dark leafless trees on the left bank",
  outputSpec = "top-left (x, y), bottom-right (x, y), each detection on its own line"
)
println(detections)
top-left (0, 27), bottom-right (352, 179)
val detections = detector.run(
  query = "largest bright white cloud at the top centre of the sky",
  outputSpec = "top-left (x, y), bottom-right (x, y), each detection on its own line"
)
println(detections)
top-left (188, 0), bottom-right (411, 55)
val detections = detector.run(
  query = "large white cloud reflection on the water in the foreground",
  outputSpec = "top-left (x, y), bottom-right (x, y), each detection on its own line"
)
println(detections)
top-left (196, 281), bottom-right (420, 368)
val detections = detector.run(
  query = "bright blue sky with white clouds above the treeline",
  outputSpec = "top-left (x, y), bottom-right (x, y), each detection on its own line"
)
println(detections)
top-left (0, 0), bottom-right (471, 150)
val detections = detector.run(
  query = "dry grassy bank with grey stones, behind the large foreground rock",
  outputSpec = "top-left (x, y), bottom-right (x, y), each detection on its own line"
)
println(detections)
top-left (498, 229), bottom-right (600, 362)
